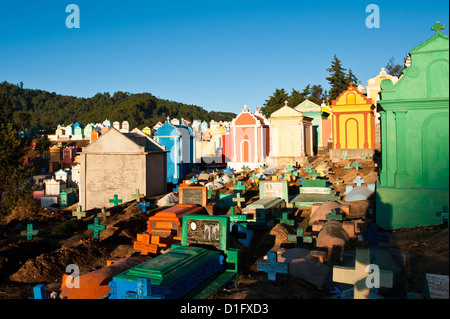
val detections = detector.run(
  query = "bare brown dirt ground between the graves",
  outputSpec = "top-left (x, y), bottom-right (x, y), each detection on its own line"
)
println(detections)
top-left (0, 157), bottom-right (449, 299)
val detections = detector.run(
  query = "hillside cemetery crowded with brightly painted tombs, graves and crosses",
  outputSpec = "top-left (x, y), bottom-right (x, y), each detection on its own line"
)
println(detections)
top-left (0, 24), bottom-right (449, 300)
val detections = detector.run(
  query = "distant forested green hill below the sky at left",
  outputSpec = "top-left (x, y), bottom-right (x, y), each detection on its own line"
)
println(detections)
top-left (0, 81), bottom-right (236, 130)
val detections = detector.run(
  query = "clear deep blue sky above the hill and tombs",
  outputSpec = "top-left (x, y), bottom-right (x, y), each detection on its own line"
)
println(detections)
top-left (0, 0), bottom-right (450, 113)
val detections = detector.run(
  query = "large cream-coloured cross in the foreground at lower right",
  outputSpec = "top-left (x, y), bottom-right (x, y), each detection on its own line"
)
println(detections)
top-left (333, 248), bottom-right (393, 299)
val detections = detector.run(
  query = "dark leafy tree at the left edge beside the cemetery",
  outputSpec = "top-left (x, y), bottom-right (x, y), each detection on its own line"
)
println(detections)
top-left (0, 123), bottom-right (34, 215)
